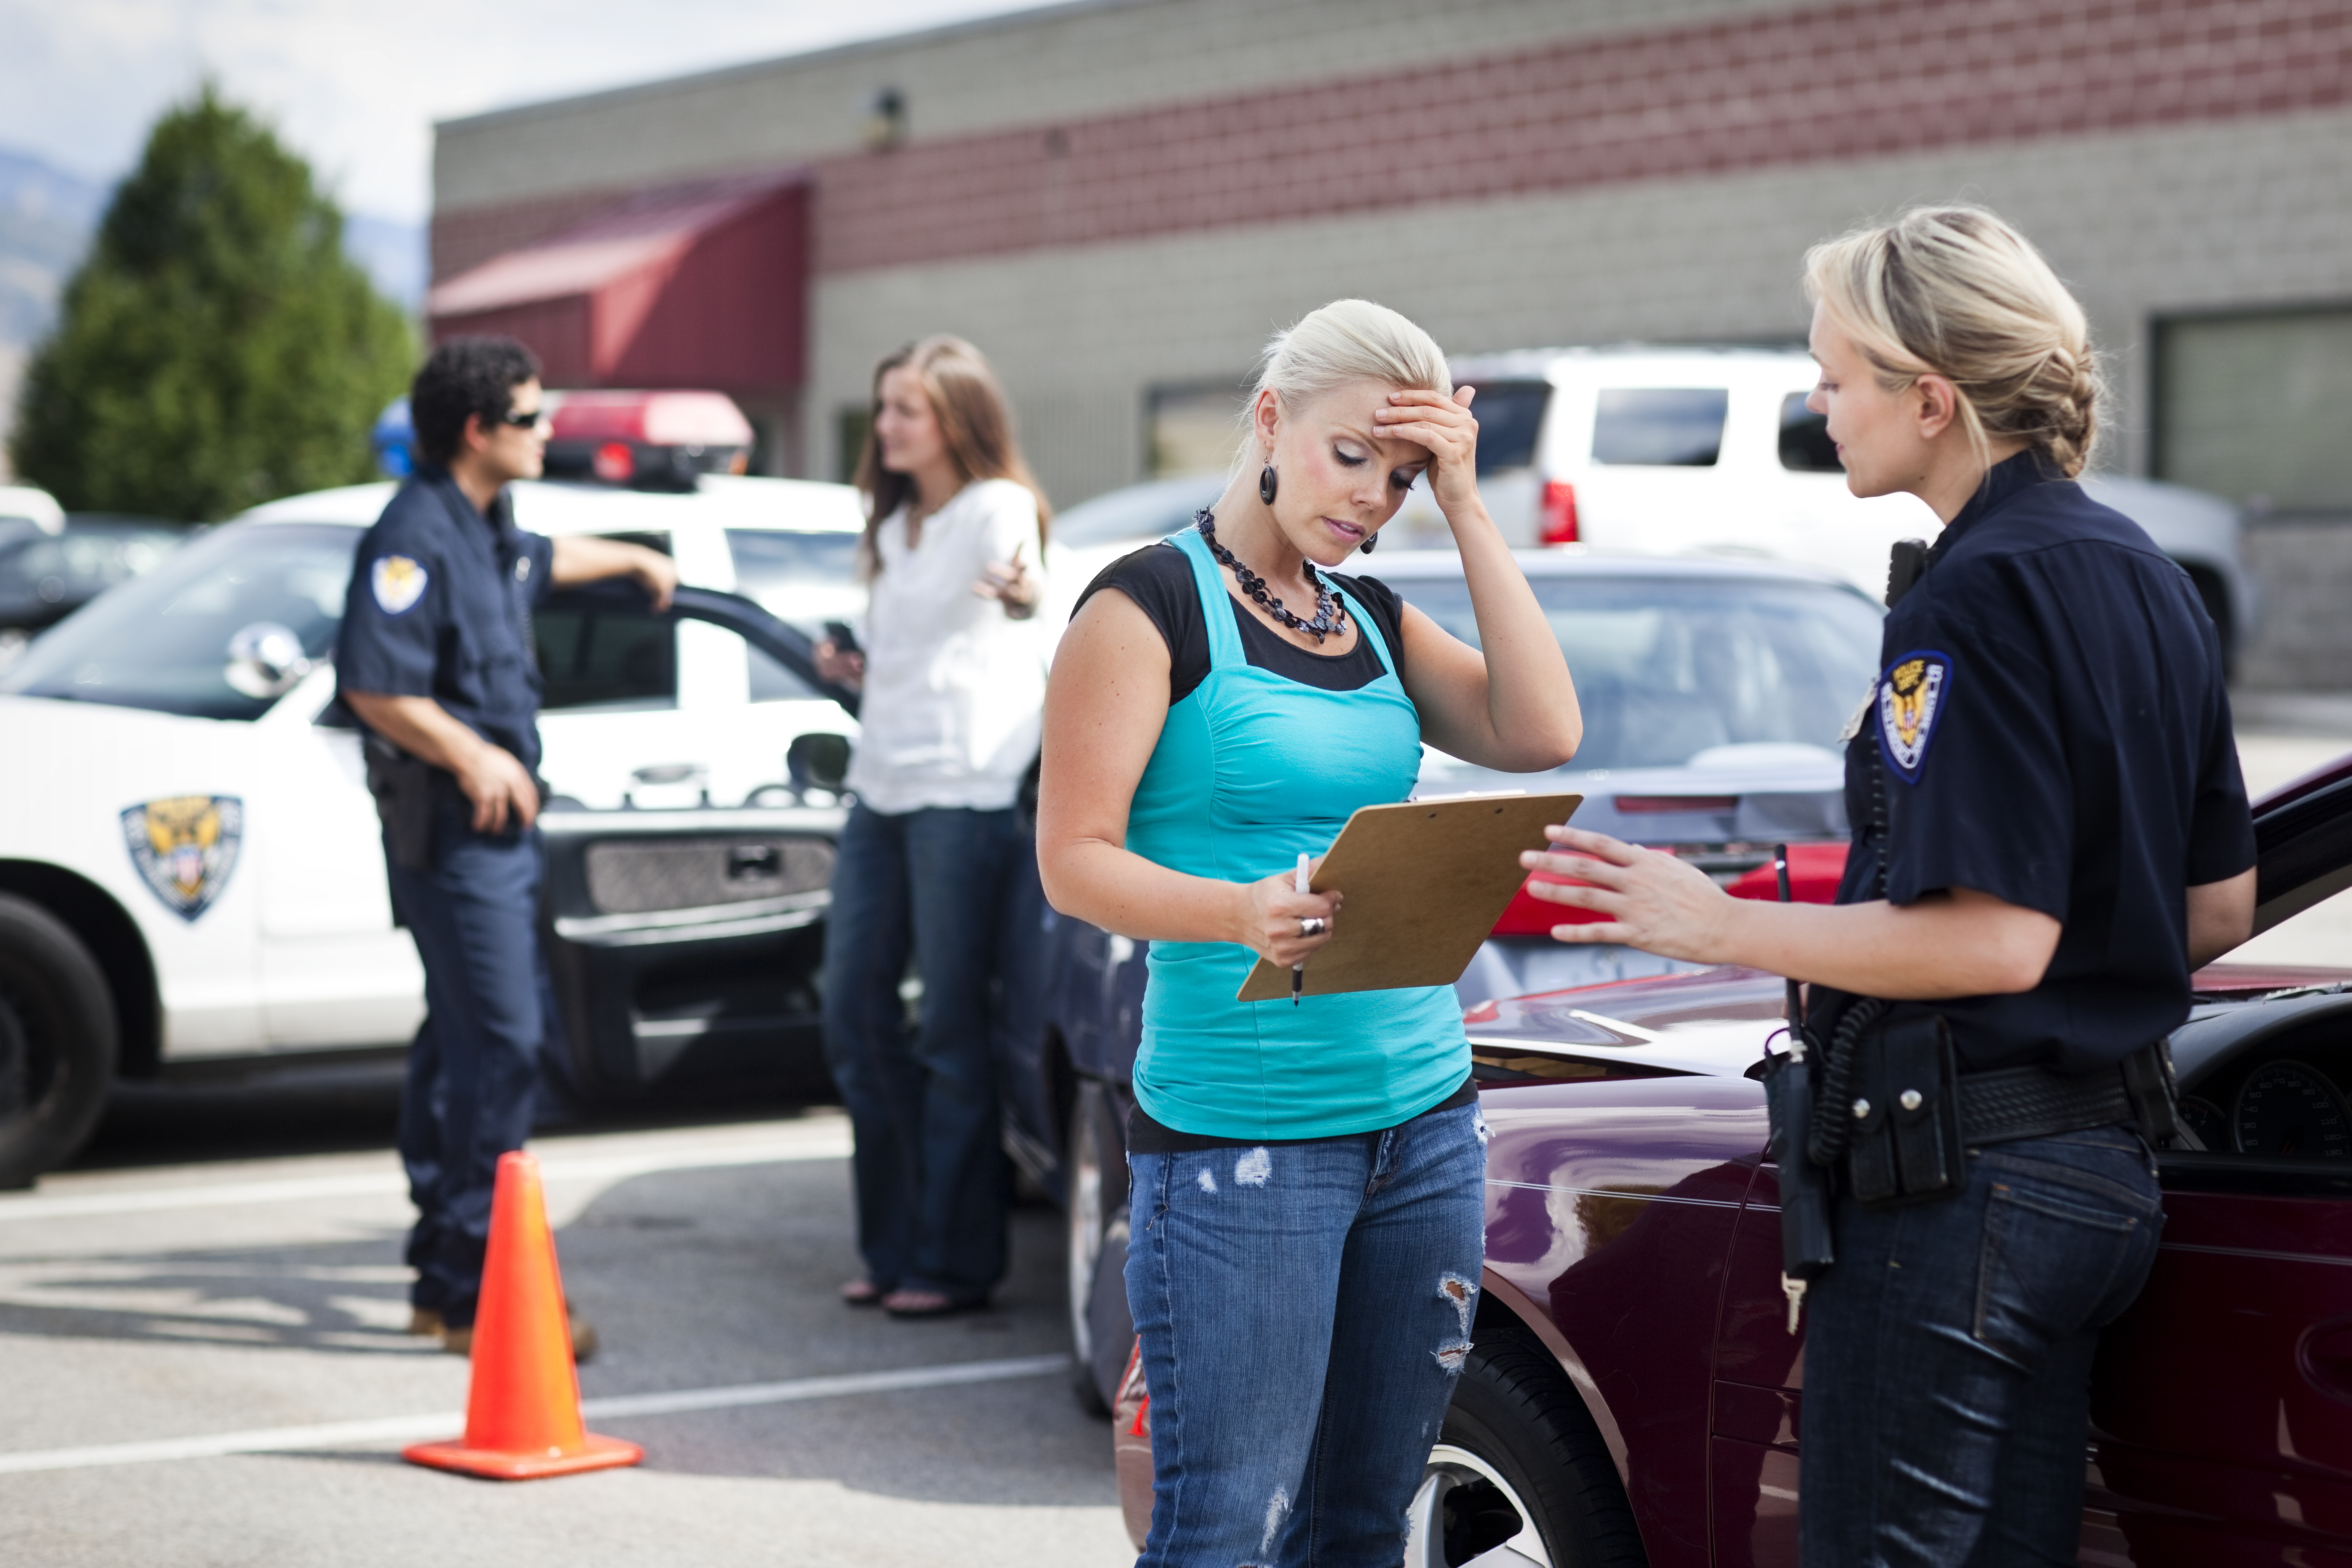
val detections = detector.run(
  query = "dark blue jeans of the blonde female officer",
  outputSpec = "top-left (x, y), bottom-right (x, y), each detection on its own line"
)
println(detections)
top-left (1797, 1128), bottom-right (2164, 1568)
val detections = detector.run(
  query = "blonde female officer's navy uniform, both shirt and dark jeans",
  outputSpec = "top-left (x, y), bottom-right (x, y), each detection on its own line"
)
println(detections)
top-left (1802, 451), bottom-right (2256, 1568)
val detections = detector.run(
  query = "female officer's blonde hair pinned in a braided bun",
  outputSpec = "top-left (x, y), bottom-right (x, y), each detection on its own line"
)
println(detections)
top-left (1804, 207), bottom-right (2105, 477)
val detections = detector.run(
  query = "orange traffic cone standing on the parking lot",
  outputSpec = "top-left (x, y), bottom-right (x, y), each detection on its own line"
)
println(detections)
top-left (400, 1152), bottom-right (645, 1481)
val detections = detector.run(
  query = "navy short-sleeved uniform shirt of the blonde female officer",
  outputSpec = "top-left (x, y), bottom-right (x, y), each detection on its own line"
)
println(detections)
top-left (1837, 451), bottom-right (2253, 1072)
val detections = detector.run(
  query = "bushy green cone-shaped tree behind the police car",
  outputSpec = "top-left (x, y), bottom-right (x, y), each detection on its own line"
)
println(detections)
top-left (9, 82), bottom-right (414, 522)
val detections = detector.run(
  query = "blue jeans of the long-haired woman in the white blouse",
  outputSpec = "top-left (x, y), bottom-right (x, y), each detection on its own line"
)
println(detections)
top-left (825, 806), bottom-right (1026, 1302)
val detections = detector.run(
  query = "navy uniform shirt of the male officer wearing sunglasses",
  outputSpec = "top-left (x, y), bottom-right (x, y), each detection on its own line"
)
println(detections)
top-left (334, 468), bottom-right (555, 774)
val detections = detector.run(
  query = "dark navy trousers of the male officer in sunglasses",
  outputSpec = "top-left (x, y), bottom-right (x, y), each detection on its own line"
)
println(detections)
top-left (386, 816), bottom-right (541, 1326)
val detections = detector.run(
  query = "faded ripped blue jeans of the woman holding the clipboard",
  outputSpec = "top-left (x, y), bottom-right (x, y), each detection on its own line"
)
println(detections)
top-left (1127, 1105), bottom-right (1486, 1568)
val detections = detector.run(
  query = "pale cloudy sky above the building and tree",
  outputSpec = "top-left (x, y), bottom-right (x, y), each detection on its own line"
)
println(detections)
top-left (0, 0), bottom-right (1035, 223)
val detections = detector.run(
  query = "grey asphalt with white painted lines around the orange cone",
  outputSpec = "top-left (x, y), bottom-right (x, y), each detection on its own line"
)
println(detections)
top-left (0, 1070), bottom-right (1131, 1568)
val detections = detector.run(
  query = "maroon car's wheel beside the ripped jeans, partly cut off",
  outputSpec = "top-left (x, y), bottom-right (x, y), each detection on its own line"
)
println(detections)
top-left (1404, 1333), bottom-right (1646, 1568)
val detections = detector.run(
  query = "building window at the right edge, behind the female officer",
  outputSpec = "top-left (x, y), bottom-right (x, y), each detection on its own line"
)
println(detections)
top-left (2154, 308), bottom-right (2352, 517)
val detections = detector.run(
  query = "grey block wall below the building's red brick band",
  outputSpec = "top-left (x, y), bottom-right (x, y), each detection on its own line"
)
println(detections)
top-left (807, 111), bottom-right (2352, 515)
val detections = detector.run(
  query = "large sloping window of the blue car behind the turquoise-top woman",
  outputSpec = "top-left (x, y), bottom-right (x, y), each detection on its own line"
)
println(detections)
top-left (1390, 574), bottom-right (1879, 771)
